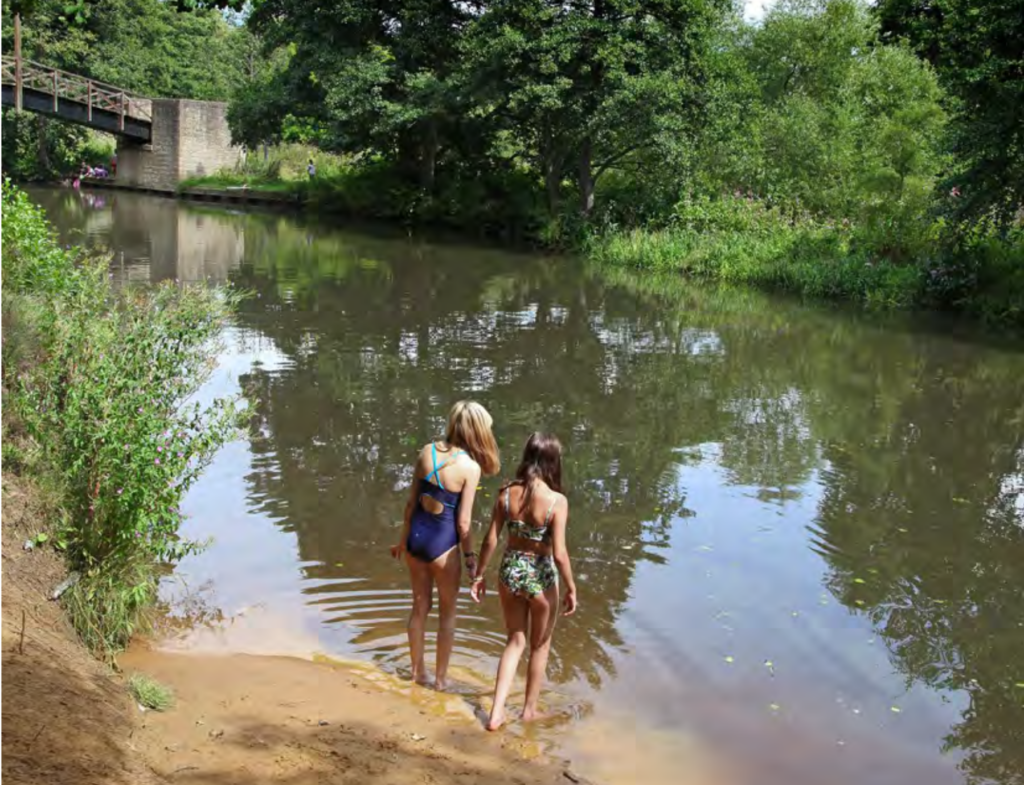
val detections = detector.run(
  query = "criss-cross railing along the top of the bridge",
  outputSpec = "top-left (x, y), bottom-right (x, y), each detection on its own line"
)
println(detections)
top-left (0, 54), bottom-right (153, 130)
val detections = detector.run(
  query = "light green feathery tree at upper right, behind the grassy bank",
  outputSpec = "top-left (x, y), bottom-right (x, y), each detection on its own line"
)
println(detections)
top-left (716, 0), bottom-right (945, 248)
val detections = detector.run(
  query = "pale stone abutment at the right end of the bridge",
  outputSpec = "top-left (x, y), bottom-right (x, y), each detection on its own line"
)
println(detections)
top-left (117, 98), bottom-right (241, 192)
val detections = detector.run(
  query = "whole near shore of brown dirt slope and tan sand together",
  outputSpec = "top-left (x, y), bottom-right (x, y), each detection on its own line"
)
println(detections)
top-left (2, 476), bottom-right (568, 785)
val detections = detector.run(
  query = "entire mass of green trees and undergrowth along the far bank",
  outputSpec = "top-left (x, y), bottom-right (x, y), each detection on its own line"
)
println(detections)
top-left (4, 0), bottom-right (1024, 325)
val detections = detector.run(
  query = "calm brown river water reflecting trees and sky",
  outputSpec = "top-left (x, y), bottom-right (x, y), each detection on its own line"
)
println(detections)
top-left (32, 190), bottom-right (1024, 785)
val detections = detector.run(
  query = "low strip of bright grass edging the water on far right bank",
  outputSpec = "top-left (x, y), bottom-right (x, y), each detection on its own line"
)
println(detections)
top-left (585, 225), bottom-right (1024, 326)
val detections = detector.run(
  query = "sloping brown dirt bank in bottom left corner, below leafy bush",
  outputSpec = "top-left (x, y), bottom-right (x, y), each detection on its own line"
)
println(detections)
top-left (2, 473), bottom-right (159, 785)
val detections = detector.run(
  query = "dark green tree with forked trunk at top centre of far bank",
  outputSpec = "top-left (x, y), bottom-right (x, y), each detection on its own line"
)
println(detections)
top-left (467, 0), bottom-right (730, 216)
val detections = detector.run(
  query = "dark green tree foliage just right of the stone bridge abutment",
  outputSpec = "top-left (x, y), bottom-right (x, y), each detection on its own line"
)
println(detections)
top-left (244, 0), bottom-right (475, 189)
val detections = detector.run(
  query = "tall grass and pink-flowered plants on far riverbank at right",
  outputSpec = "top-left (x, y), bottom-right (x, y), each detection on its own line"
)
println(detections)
top-left (583, 197), bottom-right (1024, 325)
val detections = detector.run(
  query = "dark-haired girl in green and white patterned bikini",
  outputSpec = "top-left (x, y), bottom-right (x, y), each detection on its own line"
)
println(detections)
top-left (472, 433), bottom-right (577, 731)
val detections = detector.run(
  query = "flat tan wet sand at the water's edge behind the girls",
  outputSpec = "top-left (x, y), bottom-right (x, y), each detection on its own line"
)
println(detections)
top-left (121, 648), bottom-right (568, 785)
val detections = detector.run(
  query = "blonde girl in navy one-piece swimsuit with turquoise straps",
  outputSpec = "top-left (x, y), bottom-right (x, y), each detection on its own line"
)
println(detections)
top-left (391, 401), bottom-right (501, 690)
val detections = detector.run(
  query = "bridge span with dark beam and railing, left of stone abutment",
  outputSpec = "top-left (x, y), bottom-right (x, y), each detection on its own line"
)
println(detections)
top-left (0, 55), bottom-right (153, 143)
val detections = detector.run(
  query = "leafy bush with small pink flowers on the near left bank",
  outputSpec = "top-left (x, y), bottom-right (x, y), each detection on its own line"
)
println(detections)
top-left (3, 183), bottom-right (239, 655)
